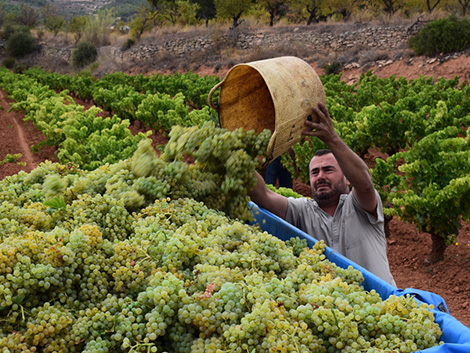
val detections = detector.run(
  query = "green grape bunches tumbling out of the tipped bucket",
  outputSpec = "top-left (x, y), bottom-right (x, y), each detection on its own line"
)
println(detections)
top-left (162, 122), bottom-right (271, 220)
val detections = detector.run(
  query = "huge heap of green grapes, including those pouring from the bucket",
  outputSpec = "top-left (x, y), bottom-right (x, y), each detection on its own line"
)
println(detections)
top-left (0, 125), bottom-right (441, 353)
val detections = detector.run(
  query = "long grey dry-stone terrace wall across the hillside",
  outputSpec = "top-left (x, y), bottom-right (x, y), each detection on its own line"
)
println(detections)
top-left (36, 24), bottom-right (416, 63)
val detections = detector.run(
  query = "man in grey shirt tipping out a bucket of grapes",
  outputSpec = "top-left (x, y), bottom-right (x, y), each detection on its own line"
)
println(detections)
top-left (250, 103), bottom-right (395, 286)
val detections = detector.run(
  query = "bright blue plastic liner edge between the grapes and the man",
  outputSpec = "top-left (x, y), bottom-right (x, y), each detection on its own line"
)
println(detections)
top-left (250, 202), bottom-right (470, 353)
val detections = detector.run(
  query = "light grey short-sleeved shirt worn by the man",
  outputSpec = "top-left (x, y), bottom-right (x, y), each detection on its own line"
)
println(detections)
top-left (286, 191), bottom-right (396, 286)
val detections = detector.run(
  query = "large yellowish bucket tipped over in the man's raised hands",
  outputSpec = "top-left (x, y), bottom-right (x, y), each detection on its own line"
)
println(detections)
top-left (208, 56), bottom-right (326, 161)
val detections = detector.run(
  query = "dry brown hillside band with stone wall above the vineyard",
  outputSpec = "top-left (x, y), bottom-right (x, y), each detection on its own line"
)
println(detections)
top-left (5, 18), bottom-right (470, 83)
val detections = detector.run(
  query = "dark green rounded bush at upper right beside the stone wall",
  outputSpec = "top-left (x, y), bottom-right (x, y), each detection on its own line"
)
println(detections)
top-left (408, 16), bottom-right (470, 56)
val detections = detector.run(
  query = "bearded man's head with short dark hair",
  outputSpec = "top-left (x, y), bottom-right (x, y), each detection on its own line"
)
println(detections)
top-left (309, 153), bottom-right (349, 206)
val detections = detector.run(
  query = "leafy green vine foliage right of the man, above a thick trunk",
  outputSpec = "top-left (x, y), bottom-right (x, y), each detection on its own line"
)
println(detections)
top-left (373, 126), bottom-right (470, 244)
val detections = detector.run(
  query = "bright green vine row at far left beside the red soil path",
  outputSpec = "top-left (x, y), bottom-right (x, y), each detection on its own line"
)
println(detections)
top-left (0, 69), bottom-right (146, 170)
